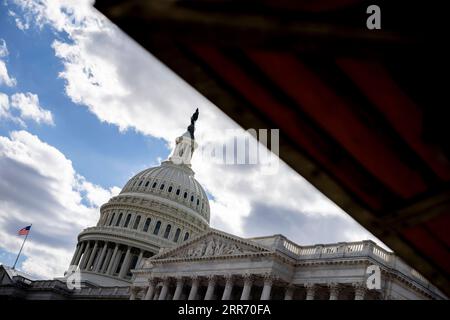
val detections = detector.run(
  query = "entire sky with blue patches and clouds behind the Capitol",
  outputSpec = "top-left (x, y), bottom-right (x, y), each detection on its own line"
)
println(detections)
top-left (0, 0), bottom-right (386, 278)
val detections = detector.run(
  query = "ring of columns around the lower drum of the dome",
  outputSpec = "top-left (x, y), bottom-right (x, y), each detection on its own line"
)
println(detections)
top-left (70, 241), bottom-right (144, 278)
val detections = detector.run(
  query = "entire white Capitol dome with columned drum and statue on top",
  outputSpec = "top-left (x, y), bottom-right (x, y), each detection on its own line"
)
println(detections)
top-left (70, 110), bottom-right (209, 286)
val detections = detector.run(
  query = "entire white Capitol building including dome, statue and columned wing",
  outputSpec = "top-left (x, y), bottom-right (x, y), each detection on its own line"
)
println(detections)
top-left (0, 113), bottom-right (446, 300)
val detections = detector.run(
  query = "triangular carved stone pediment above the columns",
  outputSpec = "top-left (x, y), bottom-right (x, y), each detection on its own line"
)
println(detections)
top-left (154, 230), bottom-right (269, 260)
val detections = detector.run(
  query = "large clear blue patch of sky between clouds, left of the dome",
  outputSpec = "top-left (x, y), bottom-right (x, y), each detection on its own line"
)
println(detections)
top-left (0, 4), bottom-right (169, 187)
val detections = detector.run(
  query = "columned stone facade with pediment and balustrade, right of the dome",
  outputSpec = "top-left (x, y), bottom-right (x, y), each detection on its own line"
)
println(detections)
top-left (130, 229), bottom-right (445, 300)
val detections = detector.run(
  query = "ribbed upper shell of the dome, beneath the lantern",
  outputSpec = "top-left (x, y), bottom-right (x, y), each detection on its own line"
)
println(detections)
top-left (120, 160), bottom-right (209, 223)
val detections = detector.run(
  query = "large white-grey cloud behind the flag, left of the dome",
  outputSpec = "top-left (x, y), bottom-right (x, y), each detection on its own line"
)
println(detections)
top-left (0, 131), bottom-right (117, 277)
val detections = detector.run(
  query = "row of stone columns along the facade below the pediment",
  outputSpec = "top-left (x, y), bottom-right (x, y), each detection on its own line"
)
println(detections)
top-left (130, 275), bottom-right (366, 300)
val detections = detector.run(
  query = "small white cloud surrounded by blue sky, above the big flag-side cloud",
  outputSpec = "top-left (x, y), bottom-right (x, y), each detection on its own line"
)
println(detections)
top-left (11, 92), bottom-right (54, 125)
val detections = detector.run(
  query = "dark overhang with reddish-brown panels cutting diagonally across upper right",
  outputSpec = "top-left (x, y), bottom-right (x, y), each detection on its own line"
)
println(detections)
top-left (95, 0), bottom-right (450, 294)
